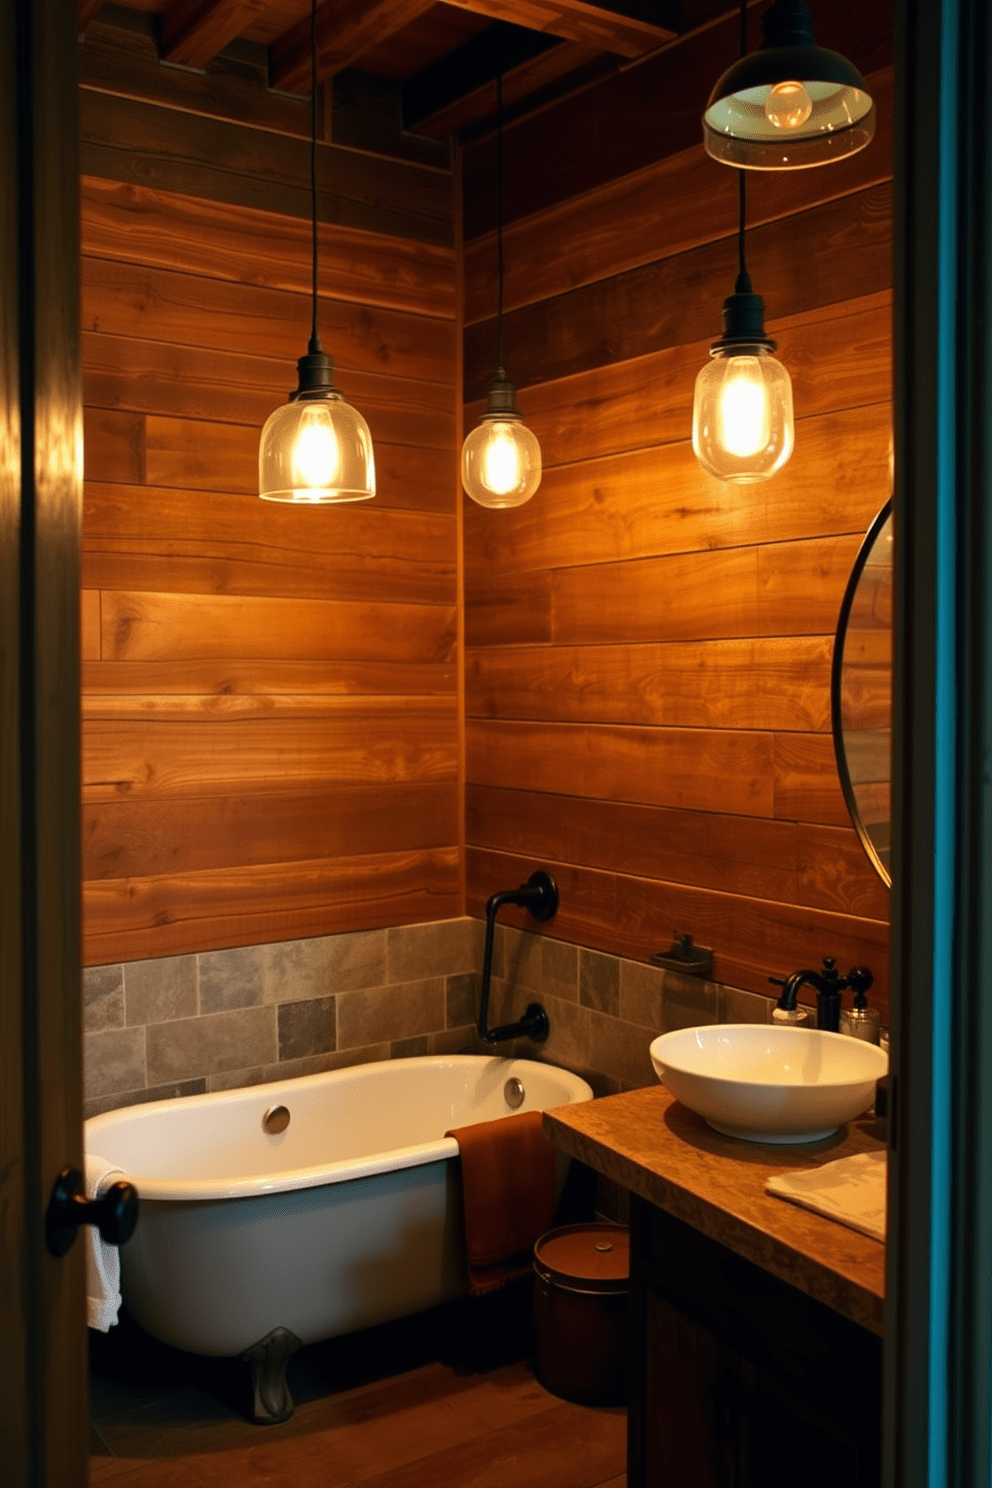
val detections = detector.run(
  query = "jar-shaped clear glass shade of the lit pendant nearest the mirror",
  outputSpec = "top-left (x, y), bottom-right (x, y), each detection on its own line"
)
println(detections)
top-left (693, 347), bottom-right (796, 485)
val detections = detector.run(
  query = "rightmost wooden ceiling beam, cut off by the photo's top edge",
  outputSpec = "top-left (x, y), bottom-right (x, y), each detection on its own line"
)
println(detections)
top-left (448, 0), bottom-right (678, 57)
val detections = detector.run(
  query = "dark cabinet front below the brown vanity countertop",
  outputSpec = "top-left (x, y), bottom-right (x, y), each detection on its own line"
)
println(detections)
top-left (628, 1196), bottom-right (882, 1488)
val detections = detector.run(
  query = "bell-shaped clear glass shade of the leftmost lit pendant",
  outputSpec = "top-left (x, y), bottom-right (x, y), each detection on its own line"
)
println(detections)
top-left (259, 393), bottom-right (375, 506)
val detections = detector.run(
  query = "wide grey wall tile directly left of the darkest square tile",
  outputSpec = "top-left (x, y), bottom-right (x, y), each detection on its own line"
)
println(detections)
top-left (147, 1007), bottom-right (277, 1083)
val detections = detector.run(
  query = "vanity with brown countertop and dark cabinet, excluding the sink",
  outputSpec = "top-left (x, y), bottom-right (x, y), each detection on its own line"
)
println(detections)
top-left (544, 1086), bottom-right (885, 1488)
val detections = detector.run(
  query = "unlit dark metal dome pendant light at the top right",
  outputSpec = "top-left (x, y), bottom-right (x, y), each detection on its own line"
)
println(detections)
top-left (703, 0), bottom-right (875, 171)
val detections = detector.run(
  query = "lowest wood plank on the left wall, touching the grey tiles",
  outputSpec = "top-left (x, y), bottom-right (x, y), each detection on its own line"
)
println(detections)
top-left (83, 847), bottom-right (460, 966)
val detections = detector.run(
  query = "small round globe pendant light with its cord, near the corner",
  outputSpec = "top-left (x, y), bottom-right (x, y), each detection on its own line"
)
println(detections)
top-left (461, 71), bottom-right (541, 507)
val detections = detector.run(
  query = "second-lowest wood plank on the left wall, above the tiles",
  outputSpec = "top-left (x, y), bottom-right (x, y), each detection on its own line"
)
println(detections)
top-left (82, 781), bottom-right (458, 879)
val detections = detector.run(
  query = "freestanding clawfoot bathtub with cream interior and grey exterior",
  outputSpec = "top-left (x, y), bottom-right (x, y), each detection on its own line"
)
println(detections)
top-left (85, 1055), bottom-right (592, 1421)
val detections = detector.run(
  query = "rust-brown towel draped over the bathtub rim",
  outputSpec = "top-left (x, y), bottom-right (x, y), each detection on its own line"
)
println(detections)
top-left (445, 1112), bottom-right (555, 1296)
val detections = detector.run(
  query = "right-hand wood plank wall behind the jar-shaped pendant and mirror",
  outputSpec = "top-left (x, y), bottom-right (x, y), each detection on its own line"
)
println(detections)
top-left (463, 0), bottom-right (892, 1003)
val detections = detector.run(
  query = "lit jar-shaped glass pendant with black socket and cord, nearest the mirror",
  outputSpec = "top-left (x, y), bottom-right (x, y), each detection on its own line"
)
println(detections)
top-left (693, 171), bottom-right (796, 485)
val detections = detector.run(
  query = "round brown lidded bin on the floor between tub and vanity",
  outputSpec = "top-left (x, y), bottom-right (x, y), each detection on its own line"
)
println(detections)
top-left (534, 1222), bottom-right (631, 1405)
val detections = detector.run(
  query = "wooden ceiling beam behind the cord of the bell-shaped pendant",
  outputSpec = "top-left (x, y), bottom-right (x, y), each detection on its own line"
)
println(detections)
top-left (269, 0), bottom-right (434, 94)
